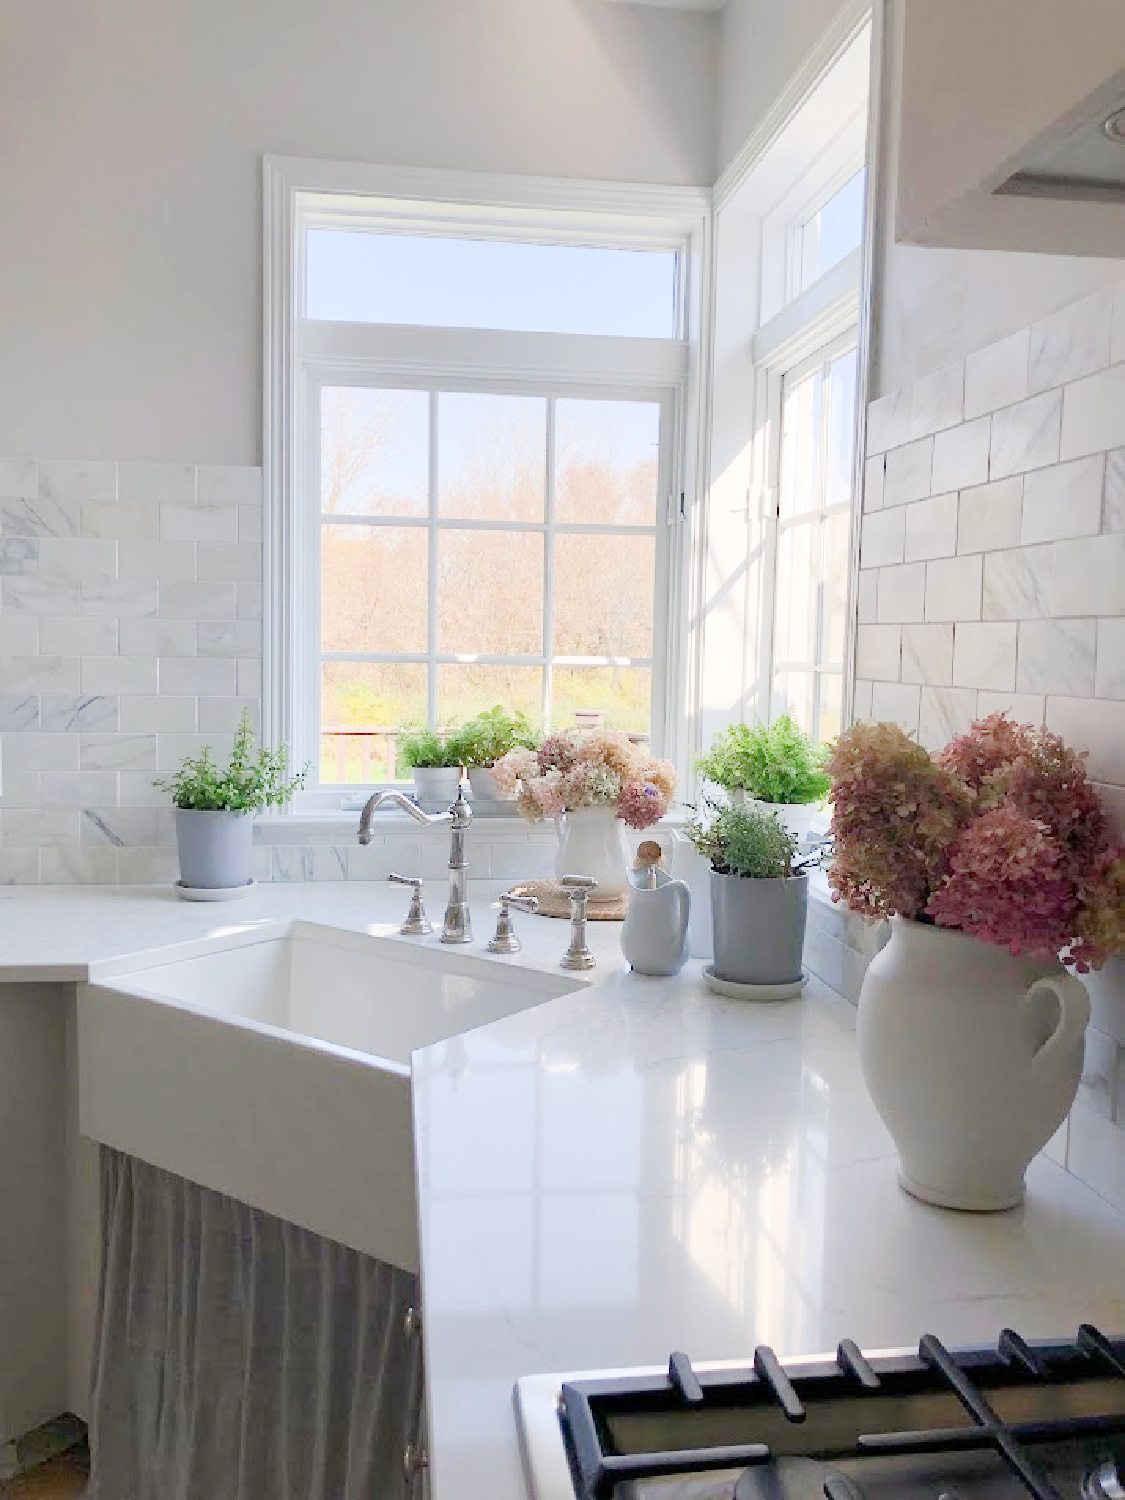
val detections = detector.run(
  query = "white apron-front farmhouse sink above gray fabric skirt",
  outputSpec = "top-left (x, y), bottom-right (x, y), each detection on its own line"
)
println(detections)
top-left (78, 923), bottom-right (582, 1271)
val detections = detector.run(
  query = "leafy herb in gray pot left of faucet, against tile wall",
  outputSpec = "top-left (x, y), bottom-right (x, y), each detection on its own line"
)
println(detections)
top-left (156, 710), bottom-right (308, 891)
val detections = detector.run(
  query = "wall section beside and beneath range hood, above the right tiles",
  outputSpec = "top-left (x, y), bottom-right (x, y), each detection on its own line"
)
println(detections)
top-left (872, 0), bottom-right (1125, 396)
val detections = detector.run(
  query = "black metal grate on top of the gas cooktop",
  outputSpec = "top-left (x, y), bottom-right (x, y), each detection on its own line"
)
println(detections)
top-left (561, 1323), bottom-right (1125, 1500)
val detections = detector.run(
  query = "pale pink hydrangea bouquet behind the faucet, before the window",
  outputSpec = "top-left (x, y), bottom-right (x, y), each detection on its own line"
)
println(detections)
top-left (492, 729), bottom-right (677, 828)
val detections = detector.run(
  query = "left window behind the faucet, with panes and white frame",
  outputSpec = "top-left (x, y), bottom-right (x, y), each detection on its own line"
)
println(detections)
top-left (264, 162), bottom-right (707, 807)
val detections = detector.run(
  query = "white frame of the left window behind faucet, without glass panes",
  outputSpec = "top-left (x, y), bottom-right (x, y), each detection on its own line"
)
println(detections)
top-left (263, 158), bottom-right (710, 810)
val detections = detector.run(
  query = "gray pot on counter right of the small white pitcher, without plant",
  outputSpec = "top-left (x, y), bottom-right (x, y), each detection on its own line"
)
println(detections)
top-left (711, 870), bottom-right (809, 984)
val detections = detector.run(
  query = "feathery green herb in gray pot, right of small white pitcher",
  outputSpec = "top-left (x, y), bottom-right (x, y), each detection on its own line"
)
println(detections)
top-left (687, 803), bottom-right (809, 987)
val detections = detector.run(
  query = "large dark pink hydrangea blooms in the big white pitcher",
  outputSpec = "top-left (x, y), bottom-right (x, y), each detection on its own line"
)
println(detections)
top-left (825, 714), bottom-right (1125, 972)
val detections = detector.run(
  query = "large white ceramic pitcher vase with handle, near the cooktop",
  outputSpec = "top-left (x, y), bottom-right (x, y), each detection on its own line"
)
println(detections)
top-left (858, 917), bottom-right (1091, 1211)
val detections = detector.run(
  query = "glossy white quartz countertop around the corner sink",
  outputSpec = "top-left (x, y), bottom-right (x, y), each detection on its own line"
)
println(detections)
top-left (0, 882), bottom-right (1125, 1500)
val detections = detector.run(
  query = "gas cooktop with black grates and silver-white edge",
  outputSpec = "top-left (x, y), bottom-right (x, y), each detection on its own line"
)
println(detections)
top-left (516, 1323), bottom-right (1125, 1500)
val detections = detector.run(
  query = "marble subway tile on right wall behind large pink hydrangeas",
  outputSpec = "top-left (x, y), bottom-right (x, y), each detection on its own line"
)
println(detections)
top-left (855, 284), bottom-right (1125, 1158)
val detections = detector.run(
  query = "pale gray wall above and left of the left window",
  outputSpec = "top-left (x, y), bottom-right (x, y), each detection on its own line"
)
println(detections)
top-left (0, 0), bottom-right (719, 464)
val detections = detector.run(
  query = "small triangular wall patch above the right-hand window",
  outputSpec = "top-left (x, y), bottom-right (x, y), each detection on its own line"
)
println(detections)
top-left (719, 0), bottom-right (842, 170)
